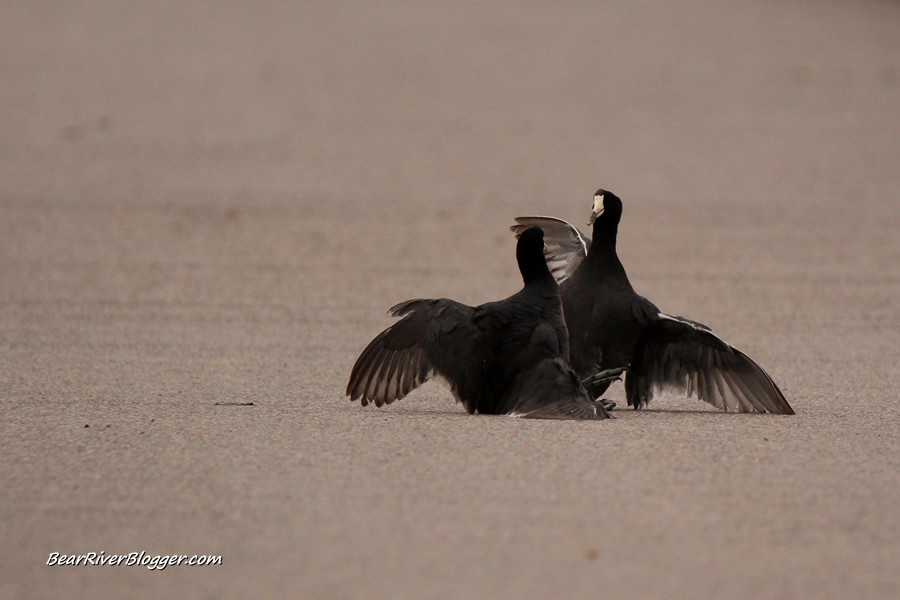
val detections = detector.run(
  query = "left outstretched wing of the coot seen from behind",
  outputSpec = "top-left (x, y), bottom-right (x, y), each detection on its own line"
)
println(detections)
top-left (346, 299), bottom-right (483, 413)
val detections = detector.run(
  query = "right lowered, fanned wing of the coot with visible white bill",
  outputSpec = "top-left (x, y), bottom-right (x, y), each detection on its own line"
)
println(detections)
top-left (625, 313), bottom-right (794, 415)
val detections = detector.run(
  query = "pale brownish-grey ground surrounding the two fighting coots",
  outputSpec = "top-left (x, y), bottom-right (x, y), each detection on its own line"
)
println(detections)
top-left (0, 0), bottom-right (900, 599)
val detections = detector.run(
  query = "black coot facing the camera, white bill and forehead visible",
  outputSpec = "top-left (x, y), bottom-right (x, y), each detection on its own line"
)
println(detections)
top-left (510, 190), bottom-right (794, 415)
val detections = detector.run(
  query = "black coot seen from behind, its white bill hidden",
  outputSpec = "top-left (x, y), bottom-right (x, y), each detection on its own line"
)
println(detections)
top-left (347, 228), bottom-right (609, 419)
